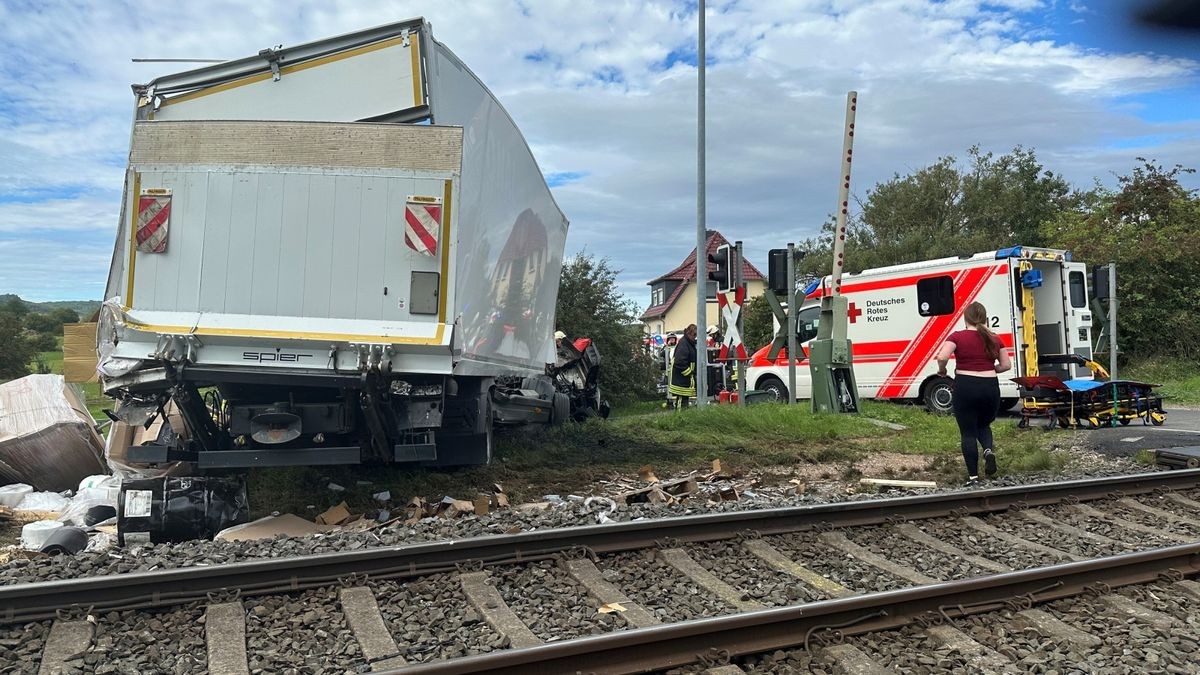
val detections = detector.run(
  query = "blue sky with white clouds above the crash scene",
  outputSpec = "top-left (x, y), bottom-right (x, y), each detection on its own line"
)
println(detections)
top-left (0, 0), bottom-right (1200, 305)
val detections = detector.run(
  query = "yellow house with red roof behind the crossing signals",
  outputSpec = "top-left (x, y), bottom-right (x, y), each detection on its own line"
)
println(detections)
top-left (641, 229), bottom-right (767, 335)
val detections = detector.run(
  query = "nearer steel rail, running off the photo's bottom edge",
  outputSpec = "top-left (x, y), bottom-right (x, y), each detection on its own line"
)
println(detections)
top-left (385, 543), bottom-right (1200, 675)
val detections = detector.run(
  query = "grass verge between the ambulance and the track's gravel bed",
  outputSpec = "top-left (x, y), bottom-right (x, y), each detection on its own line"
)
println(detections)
top-left (250, 401), bottom-right (1064, 516)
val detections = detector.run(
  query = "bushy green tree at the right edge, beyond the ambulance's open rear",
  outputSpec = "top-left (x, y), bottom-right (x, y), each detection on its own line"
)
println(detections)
top-left (1044, 157), bottom-right (1200, 359)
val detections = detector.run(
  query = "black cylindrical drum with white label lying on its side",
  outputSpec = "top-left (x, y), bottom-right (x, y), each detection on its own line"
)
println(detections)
top-left (116, 477), bottom-right (250, 546)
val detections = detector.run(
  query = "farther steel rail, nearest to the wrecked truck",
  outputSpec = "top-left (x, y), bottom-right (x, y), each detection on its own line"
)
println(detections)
top-left (0, 468), bottom-right (1200, 625)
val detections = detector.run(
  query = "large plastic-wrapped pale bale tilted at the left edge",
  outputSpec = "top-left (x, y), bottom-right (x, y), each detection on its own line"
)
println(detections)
top-left (0, 375), bottom-right (104, 490)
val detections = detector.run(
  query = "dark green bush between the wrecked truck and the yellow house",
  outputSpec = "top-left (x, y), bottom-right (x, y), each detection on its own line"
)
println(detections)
top-left (556, 253), bottom-right (656, 400)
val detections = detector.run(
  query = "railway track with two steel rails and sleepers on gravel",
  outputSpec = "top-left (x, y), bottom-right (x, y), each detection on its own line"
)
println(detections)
top-left (7, 470), bottom-right (1200, 673)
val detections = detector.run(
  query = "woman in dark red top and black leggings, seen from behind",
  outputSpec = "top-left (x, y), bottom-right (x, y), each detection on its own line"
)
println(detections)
top-left (937, 303), bottom-right (1013, 485)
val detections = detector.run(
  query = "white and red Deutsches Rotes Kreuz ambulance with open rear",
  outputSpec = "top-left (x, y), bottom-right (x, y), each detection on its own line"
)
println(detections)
top-left (746, 246), bottom-right (1092, 412)
